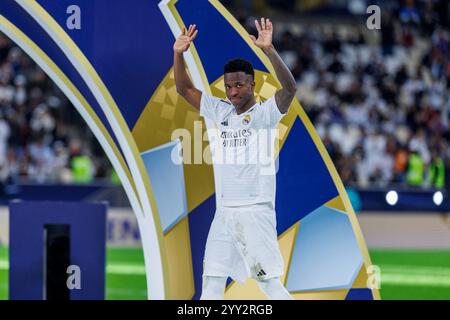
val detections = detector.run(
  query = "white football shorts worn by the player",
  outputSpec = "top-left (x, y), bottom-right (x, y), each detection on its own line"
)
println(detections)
top-left (203, 203), bottom-right (284, 283)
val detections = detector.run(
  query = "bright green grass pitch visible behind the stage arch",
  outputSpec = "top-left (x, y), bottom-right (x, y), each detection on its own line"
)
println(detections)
top-left (0, 247), bottom-right (450, 299)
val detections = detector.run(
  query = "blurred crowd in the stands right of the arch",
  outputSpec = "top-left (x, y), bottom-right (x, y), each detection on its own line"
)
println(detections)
top-left (236, 1), bottom-right (450, 189)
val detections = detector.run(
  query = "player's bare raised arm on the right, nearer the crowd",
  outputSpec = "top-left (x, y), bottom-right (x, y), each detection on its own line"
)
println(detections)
top-left (250, 18), bottom-right (297, 114)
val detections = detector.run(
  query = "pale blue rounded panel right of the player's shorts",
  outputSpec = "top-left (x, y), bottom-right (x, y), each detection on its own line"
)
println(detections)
top-left (286, 206), bottom-right (363, 292)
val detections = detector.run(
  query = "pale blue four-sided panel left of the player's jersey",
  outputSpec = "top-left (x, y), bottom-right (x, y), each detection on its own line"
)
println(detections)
top-left (141, 140), bottom-right (187, 233)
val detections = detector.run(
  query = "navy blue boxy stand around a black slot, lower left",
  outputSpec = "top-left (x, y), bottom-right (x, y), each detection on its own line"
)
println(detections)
top-left (9, 201), bottom-right (107, 300)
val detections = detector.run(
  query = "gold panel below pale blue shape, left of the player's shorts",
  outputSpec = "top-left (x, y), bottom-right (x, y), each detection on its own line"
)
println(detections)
top-left (164, 217), bottom-right (195, 299)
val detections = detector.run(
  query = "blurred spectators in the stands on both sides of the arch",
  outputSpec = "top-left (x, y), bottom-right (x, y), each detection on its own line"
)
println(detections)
top-left (0, 0), bottom-right (450, 192)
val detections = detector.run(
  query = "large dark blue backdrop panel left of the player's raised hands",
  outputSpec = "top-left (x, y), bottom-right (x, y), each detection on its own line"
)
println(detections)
top-left (38, 0), bottom-right (174, 130)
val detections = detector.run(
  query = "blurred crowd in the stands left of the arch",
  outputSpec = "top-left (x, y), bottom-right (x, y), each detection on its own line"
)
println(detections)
top-left (0, 33), bottom-right (109, 193)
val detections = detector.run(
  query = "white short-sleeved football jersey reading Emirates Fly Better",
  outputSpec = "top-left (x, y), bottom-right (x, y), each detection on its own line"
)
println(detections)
top-left (200, 93), bottom-right (284, 207)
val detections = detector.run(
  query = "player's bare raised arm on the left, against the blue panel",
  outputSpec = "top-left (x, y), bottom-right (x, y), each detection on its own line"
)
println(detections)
top-left (173, 24), bottom-right (202, 110)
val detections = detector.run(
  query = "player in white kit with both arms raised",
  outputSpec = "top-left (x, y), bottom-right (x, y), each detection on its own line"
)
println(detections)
top-left (173, 18), bottom-right (296, 299)
